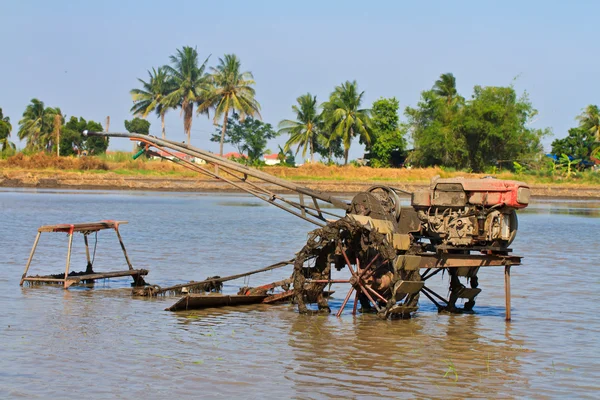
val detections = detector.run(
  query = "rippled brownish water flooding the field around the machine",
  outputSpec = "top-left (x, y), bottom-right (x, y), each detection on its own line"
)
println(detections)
top-left (0, 190), bottom-right (600, 398)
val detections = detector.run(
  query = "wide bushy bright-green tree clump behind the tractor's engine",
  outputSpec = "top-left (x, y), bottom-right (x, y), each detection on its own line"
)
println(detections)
top-left (405, 79), bottom-right (549, 172)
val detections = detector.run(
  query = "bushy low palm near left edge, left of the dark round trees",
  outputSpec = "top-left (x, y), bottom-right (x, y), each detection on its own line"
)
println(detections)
top-left (17, 99), bottom-right (62, 150)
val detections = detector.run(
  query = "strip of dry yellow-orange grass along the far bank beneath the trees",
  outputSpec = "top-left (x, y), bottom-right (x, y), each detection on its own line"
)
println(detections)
top-left (0, 153), bottom-right (600, 187)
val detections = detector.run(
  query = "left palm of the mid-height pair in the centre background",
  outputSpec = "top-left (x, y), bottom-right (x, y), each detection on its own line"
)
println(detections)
top-left (279, 93), bottom-right (321, 163)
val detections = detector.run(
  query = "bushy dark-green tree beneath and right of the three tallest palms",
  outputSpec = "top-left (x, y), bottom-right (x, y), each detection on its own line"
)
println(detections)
top-left (210, 113), bottom-right (277, 164)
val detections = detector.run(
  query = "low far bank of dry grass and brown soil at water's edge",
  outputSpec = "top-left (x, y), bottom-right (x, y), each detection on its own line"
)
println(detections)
top-left (0, 167), bottom-right (600, 199)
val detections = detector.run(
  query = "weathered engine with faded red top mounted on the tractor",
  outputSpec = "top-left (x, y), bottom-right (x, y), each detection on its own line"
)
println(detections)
top-left (411, 178), bottom-right (530, 248)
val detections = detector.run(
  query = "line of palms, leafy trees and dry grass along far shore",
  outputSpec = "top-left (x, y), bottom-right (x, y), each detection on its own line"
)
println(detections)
top-left (0, 46), bottom-right (600, 191)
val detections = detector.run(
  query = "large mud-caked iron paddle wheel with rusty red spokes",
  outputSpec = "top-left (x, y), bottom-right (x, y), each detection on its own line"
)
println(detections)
top-left (294, 218), bottom-right (423, 318)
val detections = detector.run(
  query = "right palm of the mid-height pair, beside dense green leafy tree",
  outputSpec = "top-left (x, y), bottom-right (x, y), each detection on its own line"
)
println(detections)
top-left (323, 81), bottom-right (371, 165)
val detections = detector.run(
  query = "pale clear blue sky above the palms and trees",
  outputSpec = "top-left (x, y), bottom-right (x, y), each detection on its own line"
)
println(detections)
top-left (0, 0), bottom-right (600, 159)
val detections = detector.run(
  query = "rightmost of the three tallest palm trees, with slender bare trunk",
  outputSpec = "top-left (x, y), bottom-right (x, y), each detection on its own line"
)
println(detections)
top-left (198, 54), bottom-right (261, 156)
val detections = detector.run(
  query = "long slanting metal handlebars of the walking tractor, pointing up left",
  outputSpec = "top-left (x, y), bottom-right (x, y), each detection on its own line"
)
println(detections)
top-left (83, 131), bottom-right (349, 226)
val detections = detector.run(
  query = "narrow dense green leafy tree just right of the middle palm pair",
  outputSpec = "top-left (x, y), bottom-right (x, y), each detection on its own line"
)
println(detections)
top-left (367, 97), bottom-right (406, 167)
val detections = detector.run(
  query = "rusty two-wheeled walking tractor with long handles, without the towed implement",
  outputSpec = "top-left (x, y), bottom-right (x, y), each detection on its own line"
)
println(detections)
top-left (84, 132), bottom-right (530, 320)
